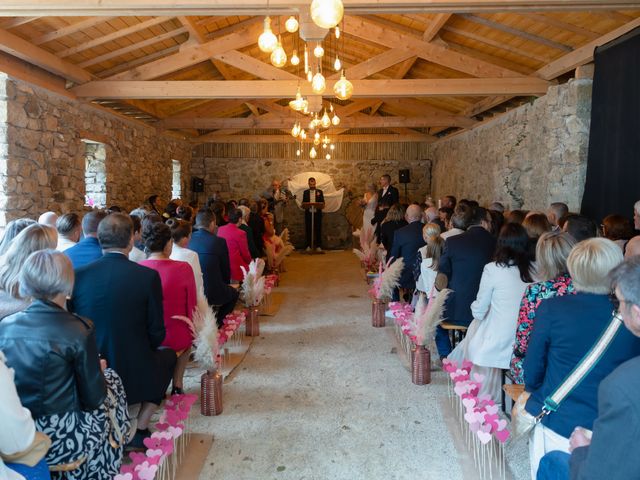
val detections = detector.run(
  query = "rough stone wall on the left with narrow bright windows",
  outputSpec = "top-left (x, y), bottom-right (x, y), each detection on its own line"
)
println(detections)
top-left (0, 74), bottom-right (191, 227)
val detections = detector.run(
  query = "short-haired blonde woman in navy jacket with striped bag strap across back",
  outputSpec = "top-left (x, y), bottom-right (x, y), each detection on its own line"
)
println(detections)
top-left (523, 238), bottom-right (640, 478)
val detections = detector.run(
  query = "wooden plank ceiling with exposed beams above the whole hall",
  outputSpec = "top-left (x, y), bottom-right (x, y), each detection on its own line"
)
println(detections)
top-left (0, 0), bottom-right (640, 143)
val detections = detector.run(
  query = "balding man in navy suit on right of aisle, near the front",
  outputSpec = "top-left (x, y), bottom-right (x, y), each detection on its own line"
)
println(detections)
top-left (387, 204), bottom-right (425, 296)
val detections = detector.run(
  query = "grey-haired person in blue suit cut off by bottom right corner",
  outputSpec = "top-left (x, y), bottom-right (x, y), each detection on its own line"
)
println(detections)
top-left (538, 257), bottom-right (640, 480)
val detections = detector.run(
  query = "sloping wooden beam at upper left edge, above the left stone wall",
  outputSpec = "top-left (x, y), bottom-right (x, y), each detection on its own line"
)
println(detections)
top-left (0, 25), bottom-right (93, 83)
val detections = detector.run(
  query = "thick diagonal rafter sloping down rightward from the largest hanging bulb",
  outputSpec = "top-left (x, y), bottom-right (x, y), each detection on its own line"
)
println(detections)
top-left (344, 17), bottom-right (524, 77)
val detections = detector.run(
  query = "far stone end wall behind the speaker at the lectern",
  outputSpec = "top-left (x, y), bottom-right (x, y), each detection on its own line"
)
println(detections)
top-left (191, 142), bottom-right (431, 248)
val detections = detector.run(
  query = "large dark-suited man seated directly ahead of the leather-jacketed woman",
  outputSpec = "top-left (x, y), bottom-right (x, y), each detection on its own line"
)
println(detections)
top-left (70, 213), bottom-right (176, 448)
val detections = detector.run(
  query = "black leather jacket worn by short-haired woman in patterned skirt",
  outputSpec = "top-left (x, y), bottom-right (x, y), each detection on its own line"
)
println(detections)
top-left (0, 300), bottom-right (106, 418)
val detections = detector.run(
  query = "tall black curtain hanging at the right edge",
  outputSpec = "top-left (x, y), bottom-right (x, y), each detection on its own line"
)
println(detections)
top-left (581, 28), bottom-right (640, 222)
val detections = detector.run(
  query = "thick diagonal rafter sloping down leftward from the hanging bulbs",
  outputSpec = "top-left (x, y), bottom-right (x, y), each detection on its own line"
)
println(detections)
top-left (109, 20), bottom-right (261, 80)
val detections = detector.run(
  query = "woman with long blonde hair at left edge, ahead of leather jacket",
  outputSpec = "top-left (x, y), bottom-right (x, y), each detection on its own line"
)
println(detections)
top-left (0, 223), bottom-right (58, 321)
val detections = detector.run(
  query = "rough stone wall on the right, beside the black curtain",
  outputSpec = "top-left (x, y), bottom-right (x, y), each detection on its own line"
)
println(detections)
top-left (429, 79), bottom-right (592, 211)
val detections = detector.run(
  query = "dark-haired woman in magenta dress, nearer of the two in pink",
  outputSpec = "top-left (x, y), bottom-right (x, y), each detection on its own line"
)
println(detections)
top-left (140, 221), bottom-right (197, 394)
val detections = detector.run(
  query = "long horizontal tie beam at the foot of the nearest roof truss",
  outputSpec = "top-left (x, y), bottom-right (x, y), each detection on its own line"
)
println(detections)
top-left (72, 77), bottom-right (549, 99)
